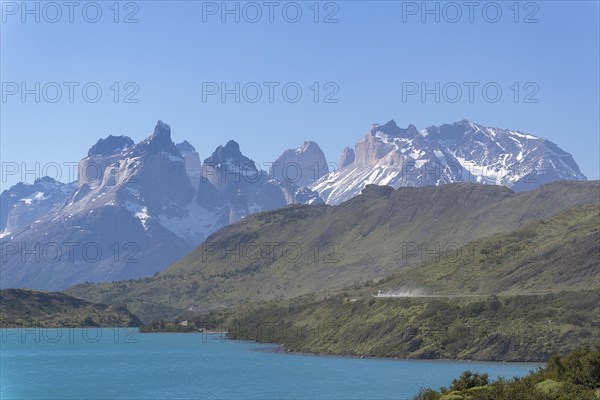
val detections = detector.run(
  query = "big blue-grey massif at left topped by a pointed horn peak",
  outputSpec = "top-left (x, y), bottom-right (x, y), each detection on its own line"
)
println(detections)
top-left (1, 121), bottom-right (199, 289)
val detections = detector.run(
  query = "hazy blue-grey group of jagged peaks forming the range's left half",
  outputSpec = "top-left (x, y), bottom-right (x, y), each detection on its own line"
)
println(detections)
top-left (0, 121), bottom-right (322, 289)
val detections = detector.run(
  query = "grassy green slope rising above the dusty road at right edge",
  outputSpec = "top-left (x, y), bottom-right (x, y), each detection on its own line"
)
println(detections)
top-left (370, 205), bottom-right (600, 295)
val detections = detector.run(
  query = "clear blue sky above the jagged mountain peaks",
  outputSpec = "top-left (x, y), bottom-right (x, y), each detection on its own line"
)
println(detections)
top-left (0, 1), bottom-right (600, 188)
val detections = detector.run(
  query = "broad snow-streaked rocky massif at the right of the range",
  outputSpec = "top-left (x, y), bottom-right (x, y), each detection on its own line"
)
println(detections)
top-left (310, 120), bottom-right (586, 204)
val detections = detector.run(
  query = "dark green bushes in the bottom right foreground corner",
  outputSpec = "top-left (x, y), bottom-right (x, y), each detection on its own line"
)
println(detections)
top-left (413, 345), bottom-right (600, 400)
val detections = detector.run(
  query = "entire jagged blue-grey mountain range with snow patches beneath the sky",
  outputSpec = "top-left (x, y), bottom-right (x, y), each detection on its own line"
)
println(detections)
top-left (0, 121), bottom-right (585, 289)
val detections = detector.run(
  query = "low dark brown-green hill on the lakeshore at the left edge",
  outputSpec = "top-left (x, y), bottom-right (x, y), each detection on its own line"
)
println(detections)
top-left (0, 289), bottom-right (141, 327)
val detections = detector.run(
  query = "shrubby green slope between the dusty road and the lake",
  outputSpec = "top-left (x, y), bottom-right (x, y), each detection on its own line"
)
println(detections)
top-left (190, 290), bottom-right (600, 361)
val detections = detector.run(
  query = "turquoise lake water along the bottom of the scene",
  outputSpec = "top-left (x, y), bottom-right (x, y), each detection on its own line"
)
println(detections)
top-left (0, 328), bottom-right (540, 399)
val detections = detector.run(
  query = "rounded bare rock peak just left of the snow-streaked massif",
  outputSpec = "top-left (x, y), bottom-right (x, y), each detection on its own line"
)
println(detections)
top-left (269, 142), bottom-right (329, 187)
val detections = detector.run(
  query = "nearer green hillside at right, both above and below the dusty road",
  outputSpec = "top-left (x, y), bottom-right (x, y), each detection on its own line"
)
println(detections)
top-left (173, 205), bottom-right (600, 361)
